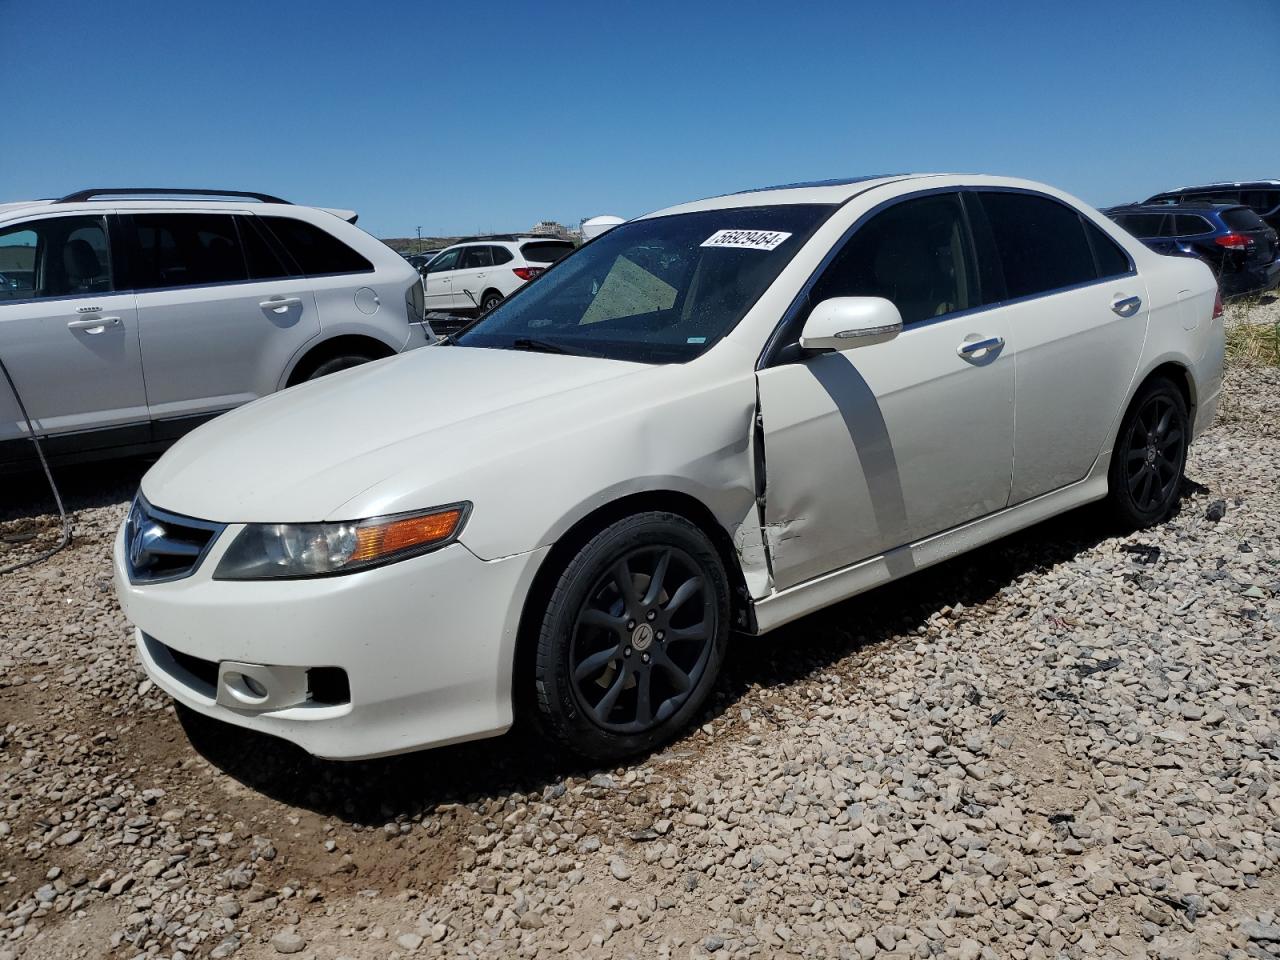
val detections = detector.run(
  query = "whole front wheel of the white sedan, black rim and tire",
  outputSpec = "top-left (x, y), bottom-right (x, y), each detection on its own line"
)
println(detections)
top-left (534, 512), bottom-right (730, 762)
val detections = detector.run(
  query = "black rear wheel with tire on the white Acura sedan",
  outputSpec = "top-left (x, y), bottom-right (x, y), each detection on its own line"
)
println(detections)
top-left (1108, 378), bottom-right (1190, 530)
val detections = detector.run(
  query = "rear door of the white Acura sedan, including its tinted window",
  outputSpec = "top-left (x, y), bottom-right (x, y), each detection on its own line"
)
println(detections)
top-left (965, 189), bottom-right (1148, 504)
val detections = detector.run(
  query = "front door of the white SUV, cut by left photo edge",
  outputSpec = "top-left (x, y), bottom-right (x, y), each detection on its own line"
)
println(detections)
top-left (0, 215), bottom-right (150, 463)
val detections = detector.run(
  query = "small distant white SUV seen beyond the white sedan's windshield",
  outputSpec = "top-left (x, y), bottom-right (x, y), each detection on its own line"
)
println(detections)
top-left (422, 236), bottom-right (573, 314)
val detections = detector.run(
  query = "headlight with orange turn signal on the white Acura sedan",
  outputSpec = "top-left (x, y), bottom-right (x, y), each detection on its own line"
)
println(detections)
top-left (214, 503), bottom-right (471, 580)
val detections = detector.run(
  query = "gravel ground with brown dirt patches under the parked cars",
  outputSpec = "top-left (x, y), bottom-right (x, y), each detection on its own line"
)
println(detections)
top-left (0, 325), bottom-right (1280, 960)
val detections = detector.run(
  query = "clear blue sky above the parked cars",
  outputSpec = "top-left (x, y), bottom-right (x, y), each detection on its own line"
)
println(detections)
top-left (0, 0), bottom-right (1280, 236)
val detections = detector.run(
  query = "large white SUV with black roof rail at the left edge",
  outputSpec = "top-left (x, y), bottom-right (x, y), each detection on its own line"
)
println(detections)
top-left (0, 188), bottom-right (428, 470)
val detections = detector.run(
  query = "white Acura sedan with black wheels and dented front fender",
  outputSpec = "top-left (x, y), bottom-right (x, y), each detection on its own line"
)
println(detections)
top-left (115, 175), bottom-right (1224, 760)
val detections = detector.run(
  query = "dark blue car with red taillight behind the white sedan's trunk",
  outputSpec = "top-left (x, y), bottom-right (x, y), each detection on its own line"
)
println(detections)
top-left (1103, 202), bottom-right (1280, 297)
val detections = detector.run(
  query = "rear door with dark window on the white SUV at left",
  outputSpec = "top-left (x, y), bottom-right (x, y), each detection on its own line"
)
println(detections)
top-left (125, 211), bottom-right (320, 439)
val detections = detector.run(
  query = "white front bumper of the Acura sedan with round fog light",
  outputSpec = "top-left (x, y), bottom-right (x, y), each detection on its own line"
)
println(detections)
top-left (114, 525), bottom-right (547, 759)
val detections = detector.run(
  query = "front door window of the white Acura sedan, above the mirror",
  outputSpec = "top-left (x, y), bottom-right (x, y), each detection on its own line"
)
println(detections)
top-left (810, 193), bottom-right (979, 324)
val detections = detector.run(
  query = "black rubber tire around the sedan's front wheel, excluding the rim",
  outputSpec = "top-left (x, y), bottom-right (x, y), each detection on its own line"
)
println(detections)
top-left (534, 512), bottom-right (730, 760)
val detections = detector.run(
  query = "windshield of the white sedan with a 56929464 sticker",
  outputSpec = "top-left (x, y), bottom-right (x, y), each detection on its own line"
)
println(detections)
top-left (457, 204), bottom-right (835, 364)
